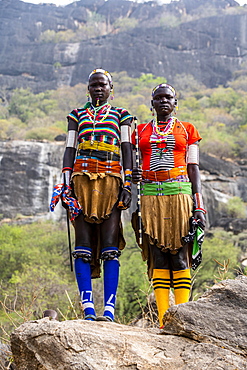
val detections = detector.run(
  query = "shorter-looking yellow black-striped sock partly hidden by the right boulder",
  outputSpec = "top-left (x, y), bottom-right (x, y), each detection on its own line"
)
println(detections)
top-left (172, 269), bottom-right (191, 304)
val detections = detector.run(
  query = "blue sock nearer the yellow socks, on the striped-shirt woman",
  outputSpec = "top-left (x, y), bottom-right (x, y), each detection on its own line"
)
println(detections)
top-left (104, 248), bottom-right (119, 320)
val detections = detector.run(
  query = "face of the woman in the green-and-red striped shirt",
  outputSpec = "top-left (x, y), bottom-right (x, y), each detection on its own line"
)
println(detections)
top-left (88, 73), bottom-right (111, 106)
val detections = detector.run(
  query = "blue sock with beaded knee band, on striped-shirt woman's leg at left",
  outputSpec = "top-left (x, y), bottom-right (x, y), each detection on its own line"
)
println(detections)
top-left (74, 247), bottom-right (96, 320)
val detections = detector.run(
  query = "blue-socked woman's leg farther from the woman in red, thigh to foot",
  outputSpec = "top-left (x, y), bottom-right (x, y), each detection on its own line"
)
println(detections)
top-left (73, 215), bottom-right (96, 320)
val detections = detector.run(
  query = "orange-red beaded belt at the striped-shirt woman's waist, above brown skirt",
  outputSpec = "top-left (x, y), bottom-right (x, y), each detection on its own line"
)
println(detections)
top-left (73, 158), bottom-right (122, 173)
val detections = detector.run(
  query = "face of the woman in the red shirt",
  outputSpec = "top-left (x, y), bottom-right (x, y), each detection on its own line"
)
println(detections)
top-left (151, 87), bottom-right (177, 118)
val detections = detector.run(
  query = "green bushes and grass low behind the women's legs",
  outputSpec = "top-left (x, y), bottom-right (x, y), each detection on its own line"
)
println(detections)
top-left (0, 222), bottom-right (244, 339)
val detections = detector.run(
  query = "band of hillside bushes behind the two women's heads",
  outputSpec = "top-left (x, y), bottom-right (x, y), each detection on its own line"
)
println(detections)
top-left (0, 69), bottom-right (247, 160)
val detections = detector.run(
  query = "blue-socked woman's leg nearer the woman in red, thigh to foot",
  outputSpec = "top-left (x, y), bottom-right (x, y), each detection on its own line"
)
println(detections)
top-left (100, 205), bottom-right (121, 321)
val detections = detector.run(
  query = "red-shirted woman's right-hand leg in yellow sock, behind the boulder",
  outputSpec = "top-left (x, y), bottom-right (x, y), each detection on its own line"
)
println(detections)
top-left (170, 245), bottom-right (191, 304)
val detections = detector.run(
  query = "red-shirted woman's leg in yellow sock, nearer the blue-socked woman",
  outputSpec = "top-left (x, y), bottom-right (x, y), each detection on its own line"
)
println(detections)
top-left (150, 245), bottom-right (170, 327)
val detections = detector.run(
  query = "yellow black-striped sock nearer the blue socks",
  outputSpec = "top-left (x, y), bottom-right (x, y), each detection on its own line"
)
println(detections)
top-left (152, 269), bottom-right (171, 326)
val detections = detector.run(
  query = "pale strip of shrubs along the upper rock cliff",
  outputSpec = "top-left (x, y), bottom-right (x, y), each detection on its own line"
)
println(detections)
top-left (37, 1), bottom-right (246, 43)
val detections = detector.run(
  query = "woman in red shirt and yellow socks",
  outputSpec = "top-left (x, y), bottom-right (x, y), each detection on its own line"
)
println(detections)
top-left (132, 84), bottom-right (206, 327)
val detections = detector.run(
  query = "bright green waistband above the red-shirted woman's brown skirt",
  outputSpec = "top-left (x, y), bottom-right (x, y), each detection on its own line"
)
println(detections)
top-left (141, 182), bottom-right (192, 195)
